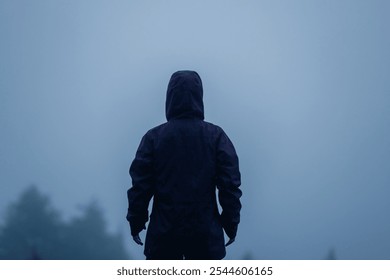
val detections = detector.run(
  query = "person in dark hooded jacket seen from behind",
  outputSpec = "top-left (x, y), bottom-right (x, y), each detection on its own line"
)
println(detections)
top-left (126, 71), bottom-right (241, 259)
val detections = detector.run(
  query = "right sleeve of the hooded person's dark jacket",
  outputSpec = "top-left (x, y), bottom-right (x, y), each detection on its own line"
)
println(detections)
top-left (216, 131), bottom-right (242, 238)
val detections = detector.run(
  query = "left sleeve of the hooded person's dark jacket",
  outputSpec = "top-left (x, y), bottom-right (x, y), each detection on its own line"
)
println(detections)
top-left (126, 134), bottom-right (154, 236)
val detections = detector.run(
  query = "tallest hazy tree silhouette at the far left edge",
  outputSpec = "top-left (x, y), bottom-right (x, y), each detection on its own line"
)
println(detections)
top-left (0, 186), bottom-right (62, 259)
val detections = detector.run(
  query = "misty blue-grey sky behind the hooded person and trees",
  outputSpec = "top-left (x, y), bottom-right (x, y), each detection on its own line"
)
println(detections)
top-left (0, 0), bottom-right (390, 259)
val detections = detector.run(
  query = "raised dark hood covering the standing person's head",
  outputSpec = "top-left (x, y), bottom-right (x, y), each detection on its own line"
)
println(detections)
top-left (165, 70), bottom-right (204, 121)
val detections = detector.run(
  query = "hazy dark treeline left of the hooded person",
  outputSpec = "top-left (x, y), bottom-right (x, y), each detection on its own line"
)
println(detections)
top-left (0, 186), bottom-right (128, 260)
